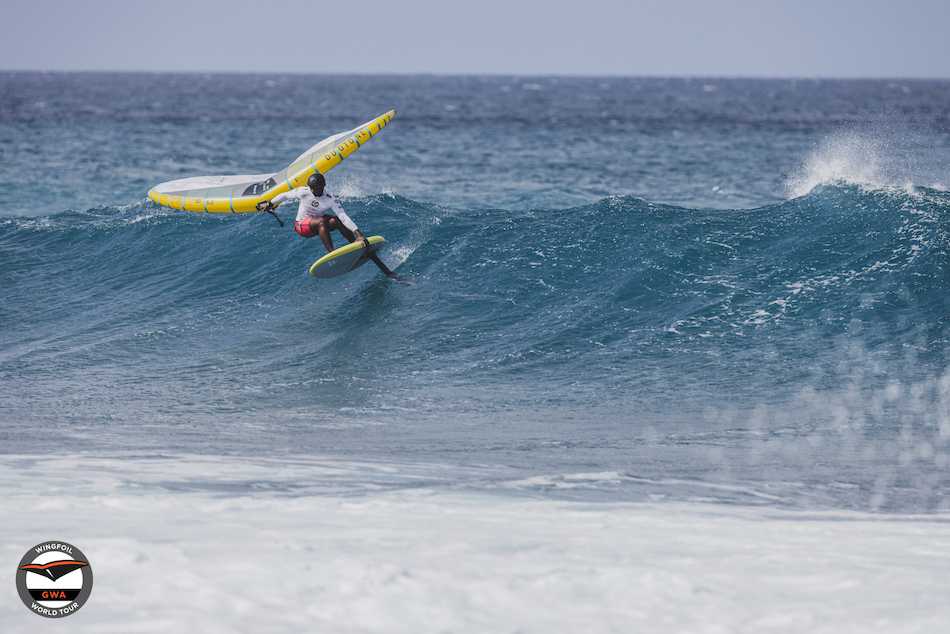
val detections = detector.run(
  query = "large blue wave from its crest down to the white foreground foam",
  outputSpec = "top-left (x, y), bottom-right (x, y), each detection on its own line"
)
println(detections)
top-left (0, 184), bottom-right (950, 508)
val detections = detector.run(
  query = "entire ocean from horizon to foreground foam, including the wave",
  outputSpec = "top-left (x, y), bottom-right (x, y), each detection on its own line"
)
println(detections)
top-left (0, 72), bottom-right (950, 633)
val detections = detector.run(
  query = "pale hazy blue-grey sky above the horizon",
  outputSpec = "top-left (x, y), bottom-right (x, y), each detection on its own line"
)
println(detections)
top-left (7, 0), bottom-right (950, 78)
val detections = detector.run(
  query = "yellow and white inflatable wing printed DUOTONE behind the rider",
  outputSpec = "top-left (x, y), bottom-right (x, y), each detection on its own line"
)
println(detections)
top-left (148, 110), bottom-right (396, 214)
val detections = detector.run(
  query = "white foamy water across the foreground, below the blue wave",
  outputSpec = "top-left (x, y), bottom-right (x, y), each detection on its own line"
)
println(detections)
top-left (0, 456), bottom-right (950, 634)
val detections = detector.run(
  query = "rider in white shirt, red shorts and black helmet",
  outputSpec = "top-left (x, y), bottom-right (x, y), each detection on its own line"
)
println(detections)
top-left (257, 172), bottom-right (369, 252)
